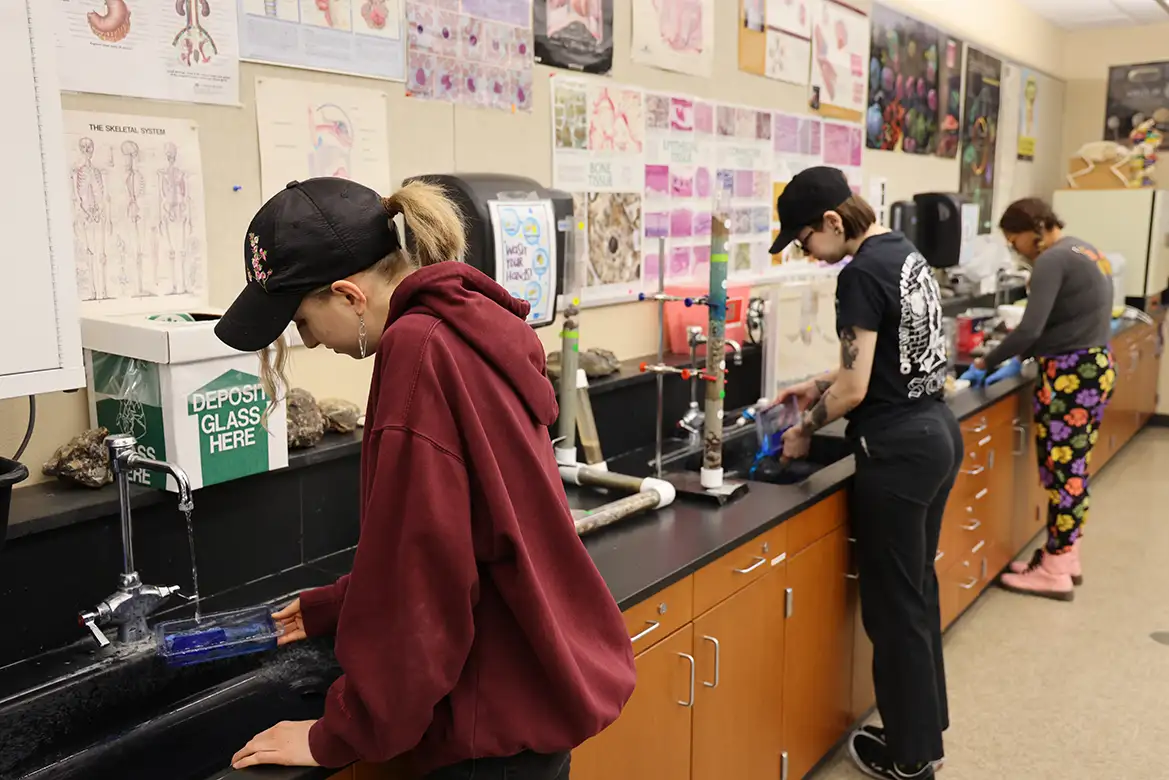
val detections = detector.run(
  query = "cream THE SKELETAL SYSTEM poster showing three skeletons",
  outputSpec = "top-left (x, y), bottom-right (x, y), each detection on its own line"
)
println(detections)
top-left (64, 111), bottom-right (207, 313)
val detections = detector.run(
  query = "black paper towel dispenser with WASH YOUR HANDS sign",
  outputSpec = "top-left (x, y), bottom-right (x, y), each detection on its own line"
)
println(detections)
top-left (403, 173), bottom-right (573, 327)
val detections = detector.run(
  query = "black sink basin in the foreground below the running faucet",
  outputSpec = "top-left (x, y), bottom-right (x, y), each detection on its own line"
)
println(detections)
top-left (0, 642), bottom-right (339, 780)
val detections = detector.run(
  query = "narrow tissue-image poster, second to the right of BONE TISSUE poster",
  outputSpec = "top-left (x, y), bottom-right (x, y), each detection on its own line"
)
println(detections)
top-left (710, 103), bottom-right (774, 277)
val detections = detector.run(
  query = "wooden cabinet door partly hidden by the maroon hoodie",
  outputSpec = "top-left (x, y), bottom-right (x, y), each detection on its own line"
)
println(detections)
top-left (573, 624), bottom-right (699, 780)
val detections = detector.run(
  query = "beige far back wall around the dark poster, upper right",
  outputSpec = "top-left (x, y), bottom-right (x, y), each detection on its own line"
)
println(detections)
top-left (1063, 25), bottom-right (1169, 187)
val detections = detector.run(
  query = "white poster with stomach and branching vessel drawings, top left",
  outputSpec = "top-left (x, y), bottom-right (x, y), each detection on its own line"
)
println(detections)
top-left (55, 0), bottom-right (240, 105)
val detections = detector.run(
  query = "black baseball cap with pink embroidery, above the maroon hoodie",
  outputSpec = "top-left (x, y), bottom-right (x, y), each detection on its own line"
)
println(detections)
top-left (215, 178), bottom-right (401, 352)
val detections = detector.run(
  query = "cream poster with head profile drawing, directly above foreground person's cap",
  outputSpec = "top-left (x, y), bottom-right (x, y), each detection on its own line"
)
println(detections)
top-left (256, 76), bottom-right (393, 200)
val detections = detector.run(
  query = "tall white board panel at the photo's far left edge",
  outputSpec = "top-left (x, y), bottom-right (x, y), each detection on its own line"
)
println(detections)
top-left (0, 0), bottom-right (85, 399)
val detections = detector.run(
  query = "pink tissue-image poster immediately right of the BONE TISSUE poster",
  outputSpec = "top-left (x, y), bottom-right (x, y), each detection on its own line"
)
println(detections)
top-left (643, 94), bottom-right (715, 288)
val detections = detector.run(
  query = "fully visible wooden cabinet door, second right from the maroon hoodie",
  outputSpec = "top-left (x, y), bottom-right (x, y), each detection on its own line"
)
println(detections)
top-left (692, 564), bottom-right (787, 780)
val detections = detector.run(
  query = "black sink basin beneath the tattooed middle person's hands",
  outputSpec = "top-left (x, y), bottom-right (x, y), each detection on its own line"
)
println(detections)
top-left (663, 427), bottom-right (852, 484)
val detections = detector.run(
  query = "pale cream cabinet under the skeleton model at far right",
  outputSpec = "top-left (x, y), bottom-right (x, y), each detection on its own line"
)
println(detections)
top-left (1052, 189), bottom-right (1169, 299)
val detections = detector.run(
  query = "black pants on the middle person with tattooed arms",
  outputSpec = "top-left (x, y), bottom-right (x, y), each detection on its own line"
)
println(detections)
top-left (851, 403), bottom-right (963, 764)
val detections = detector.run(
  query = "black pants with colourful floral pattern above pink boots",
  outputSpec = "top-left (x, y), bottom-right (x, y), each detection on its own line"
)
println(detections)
top-left (1035, 347), bottom-right (1116, 554)
